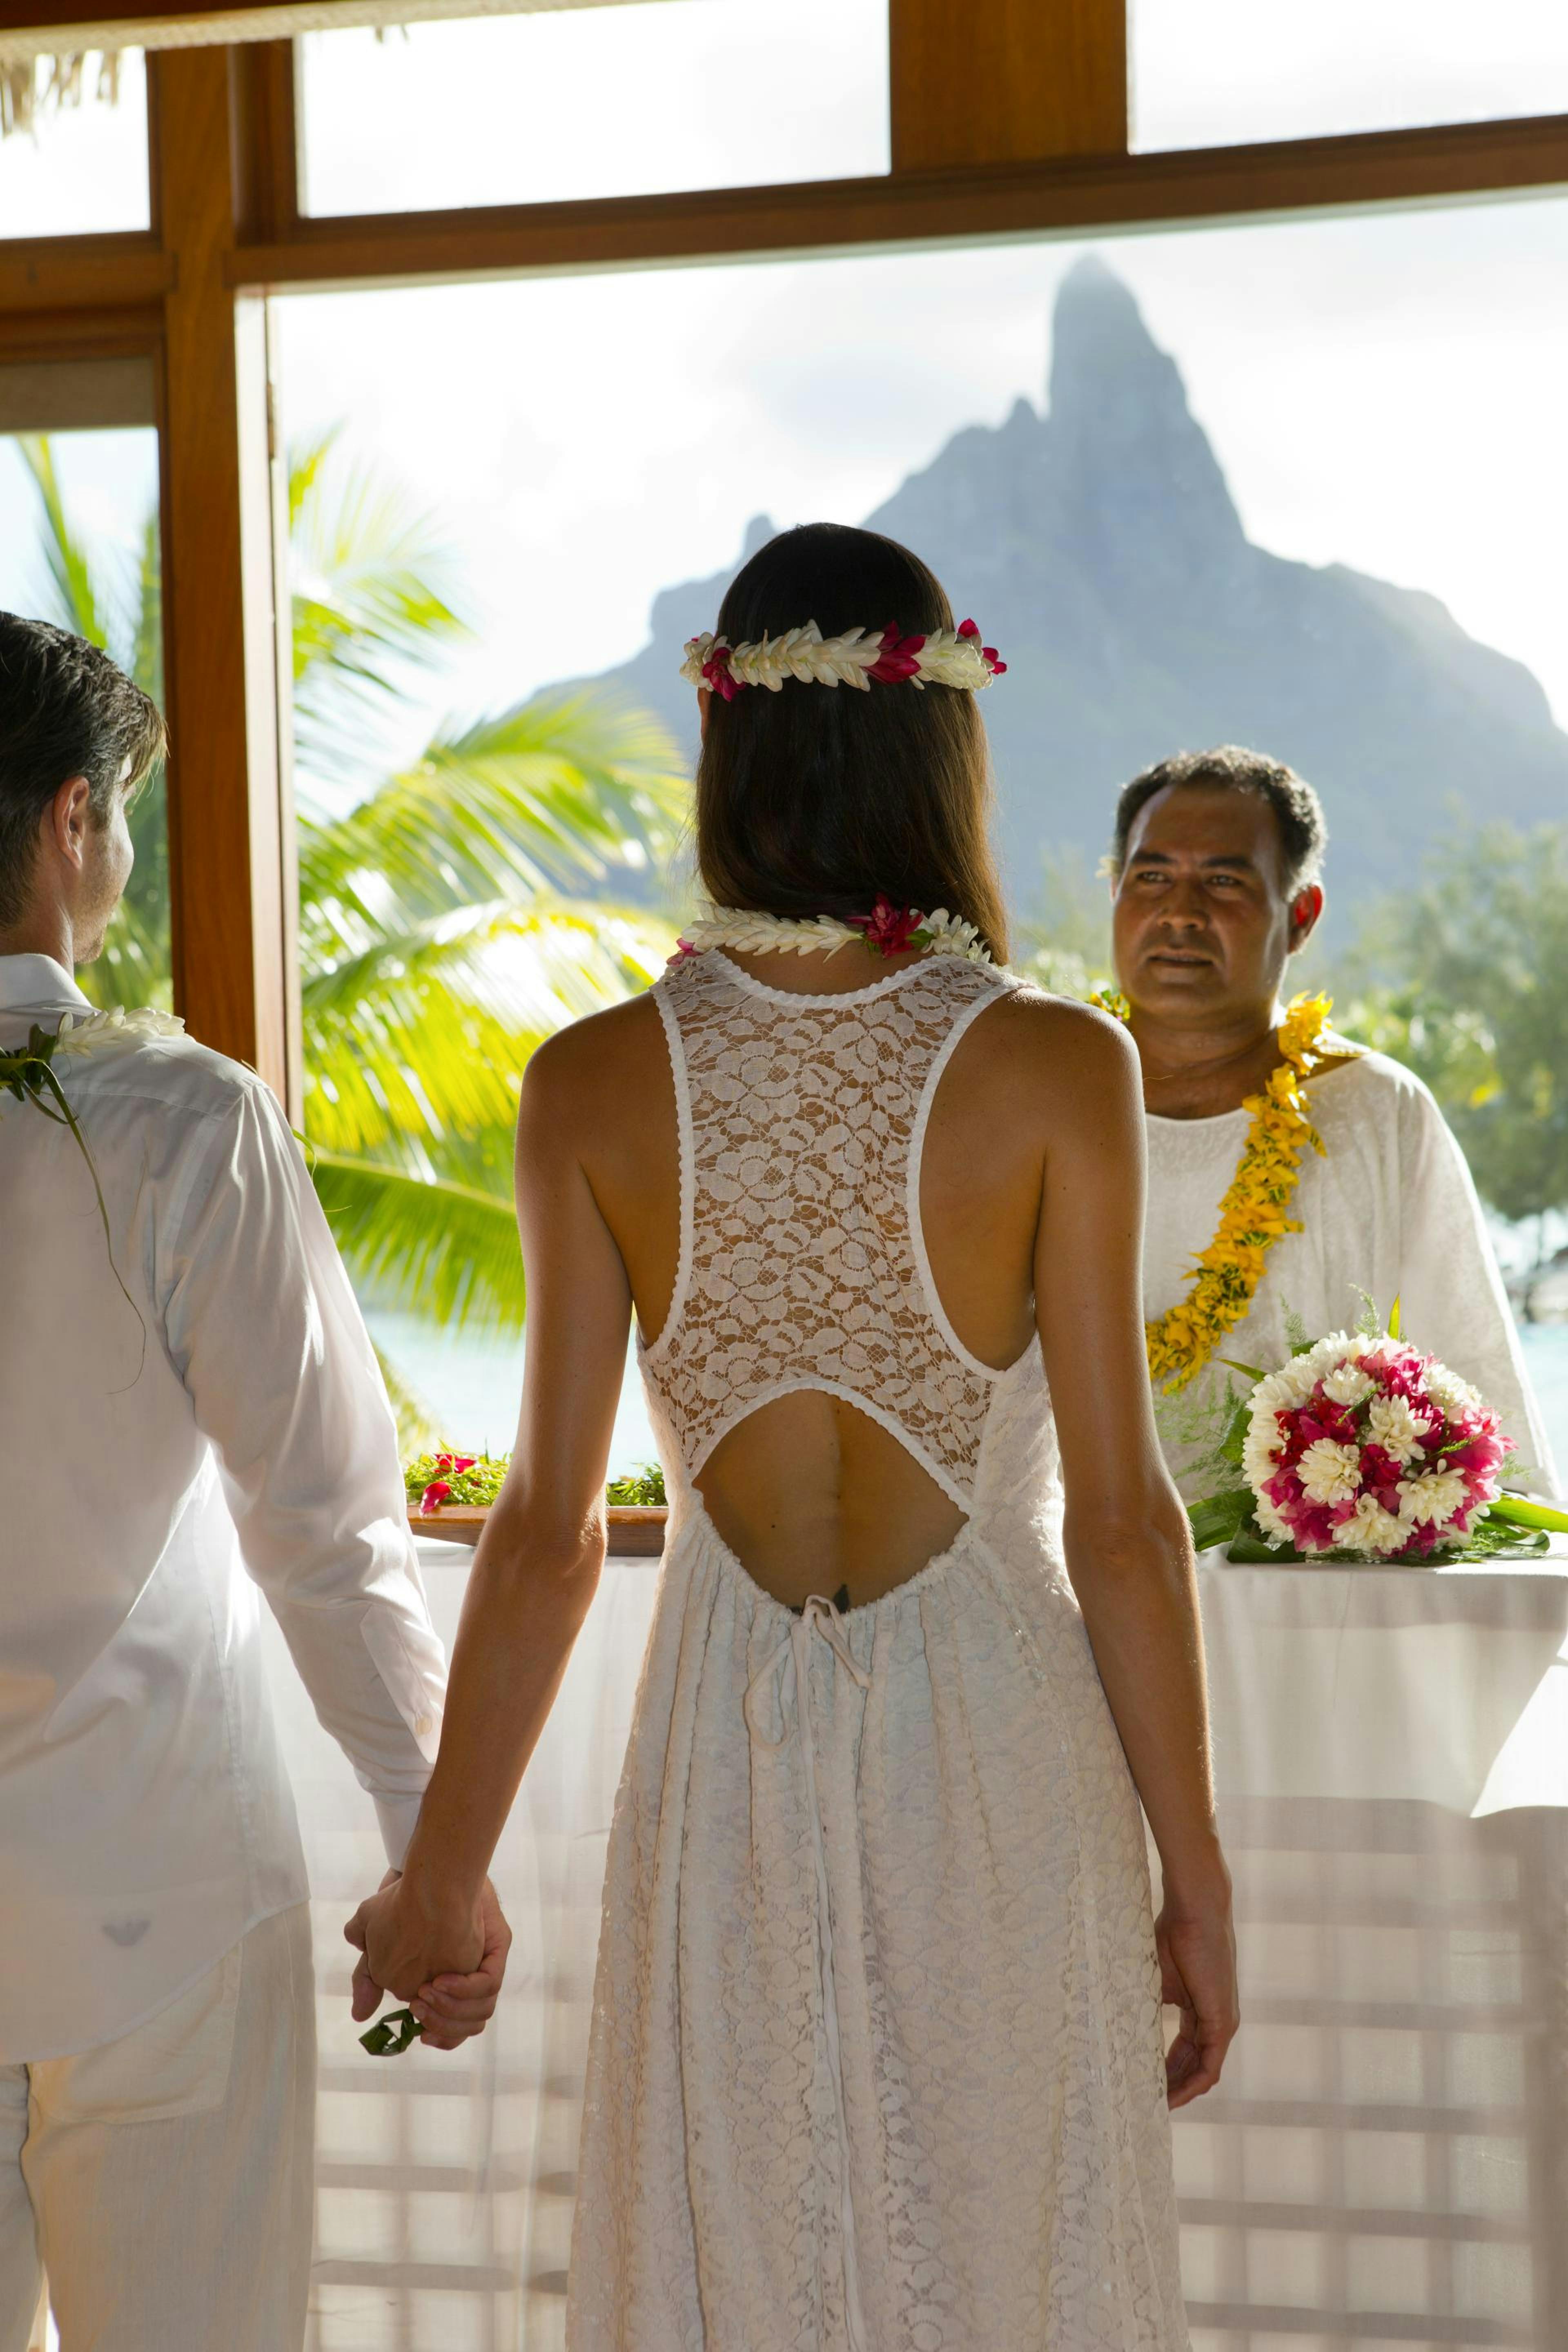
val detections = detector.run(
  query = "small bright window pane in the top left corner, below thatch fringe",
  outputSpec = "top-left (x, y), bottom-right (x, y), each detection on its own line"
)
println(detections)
top-left (0, 49), bottom-right (153, 238)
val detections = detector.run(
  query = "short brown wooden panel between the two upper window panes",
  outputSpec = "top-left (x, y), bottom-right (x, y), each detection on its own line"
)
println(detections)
top-left (889, 0), bottom-right (1126, 172)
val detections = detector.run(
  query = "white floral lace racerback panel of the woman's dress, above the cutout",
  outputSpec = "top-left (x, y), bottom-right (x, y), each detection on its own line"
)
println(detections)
top-left (644, 950), bottom-right (1009, 1508)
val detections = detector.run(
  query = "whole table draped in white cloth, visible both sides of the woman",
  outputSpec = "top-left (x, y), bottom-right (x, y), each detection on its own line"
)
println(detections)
top-left (270, 1543), bottom-right (1568, 2352)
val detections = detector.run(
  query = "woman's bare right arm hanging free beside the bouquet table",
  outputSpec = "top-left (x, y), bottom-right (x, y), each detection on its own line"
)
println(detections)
top-left (1034, 1007), bottom-right (1236, 2105)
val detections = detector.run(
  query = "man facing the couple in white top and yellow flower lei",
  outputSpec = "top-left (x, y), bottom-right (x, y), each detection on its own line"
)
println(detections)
top-left (1109, 746), bottom-right (1556, 1494)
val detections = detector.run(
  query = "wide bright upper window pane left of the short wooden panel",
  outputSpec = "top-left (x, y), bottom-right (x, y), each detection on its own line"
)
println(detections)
top-left (303, 0), bottom-right (889, 214)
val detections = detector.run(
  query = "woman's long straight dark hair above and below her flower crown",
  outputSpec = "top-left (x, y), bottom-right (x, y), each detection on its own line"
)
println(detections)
top-left (696, 522), bottom-right (1006, 962)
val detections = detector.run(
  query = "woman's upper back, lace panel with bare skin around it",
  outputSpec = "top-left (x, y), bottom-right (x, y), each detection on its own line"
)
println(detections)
top-left (557, 927), bottom-right (1098, 1604)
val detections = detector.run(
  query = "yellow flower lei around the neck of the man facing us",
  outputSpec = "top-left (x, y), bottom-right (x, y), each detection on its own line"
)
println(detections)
top-left (1096, 993), bottom-right (1354, 1390)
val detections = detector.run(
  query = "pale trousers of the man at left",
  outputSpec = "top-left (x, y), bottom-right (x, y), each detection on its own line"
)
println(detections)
top-left (0, 1903), bottom-right (315, 2352)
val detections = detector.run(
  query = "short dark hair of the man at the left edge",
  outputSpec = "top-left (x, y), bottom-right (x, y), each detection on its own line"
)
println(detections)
top-left (0, 612), bottom-right (167, 924)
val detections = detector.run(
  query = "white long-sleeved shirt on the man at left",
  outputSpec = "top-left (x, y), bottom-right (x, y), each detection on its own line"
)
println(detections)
top-left (0, 955), bottom-right (444, 2063)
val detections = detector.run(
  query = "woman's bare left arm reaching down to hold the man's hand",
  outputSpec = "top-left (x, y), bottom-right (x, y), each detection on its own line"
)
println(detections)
top-left (345, 1030), bottom-right (633, 2018)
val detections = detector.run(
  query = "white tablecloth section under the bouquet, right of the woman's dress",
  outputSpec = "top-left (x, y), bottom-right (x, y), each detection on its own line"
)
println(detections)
top-left (1176, 1559), bottom-right (1568, 2352)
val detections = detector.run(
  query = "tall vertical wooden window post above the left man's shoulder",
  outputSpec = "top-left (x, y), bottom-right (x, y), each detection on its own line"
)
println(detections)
top-left (148, 49), bottom-right (296, 1103)
